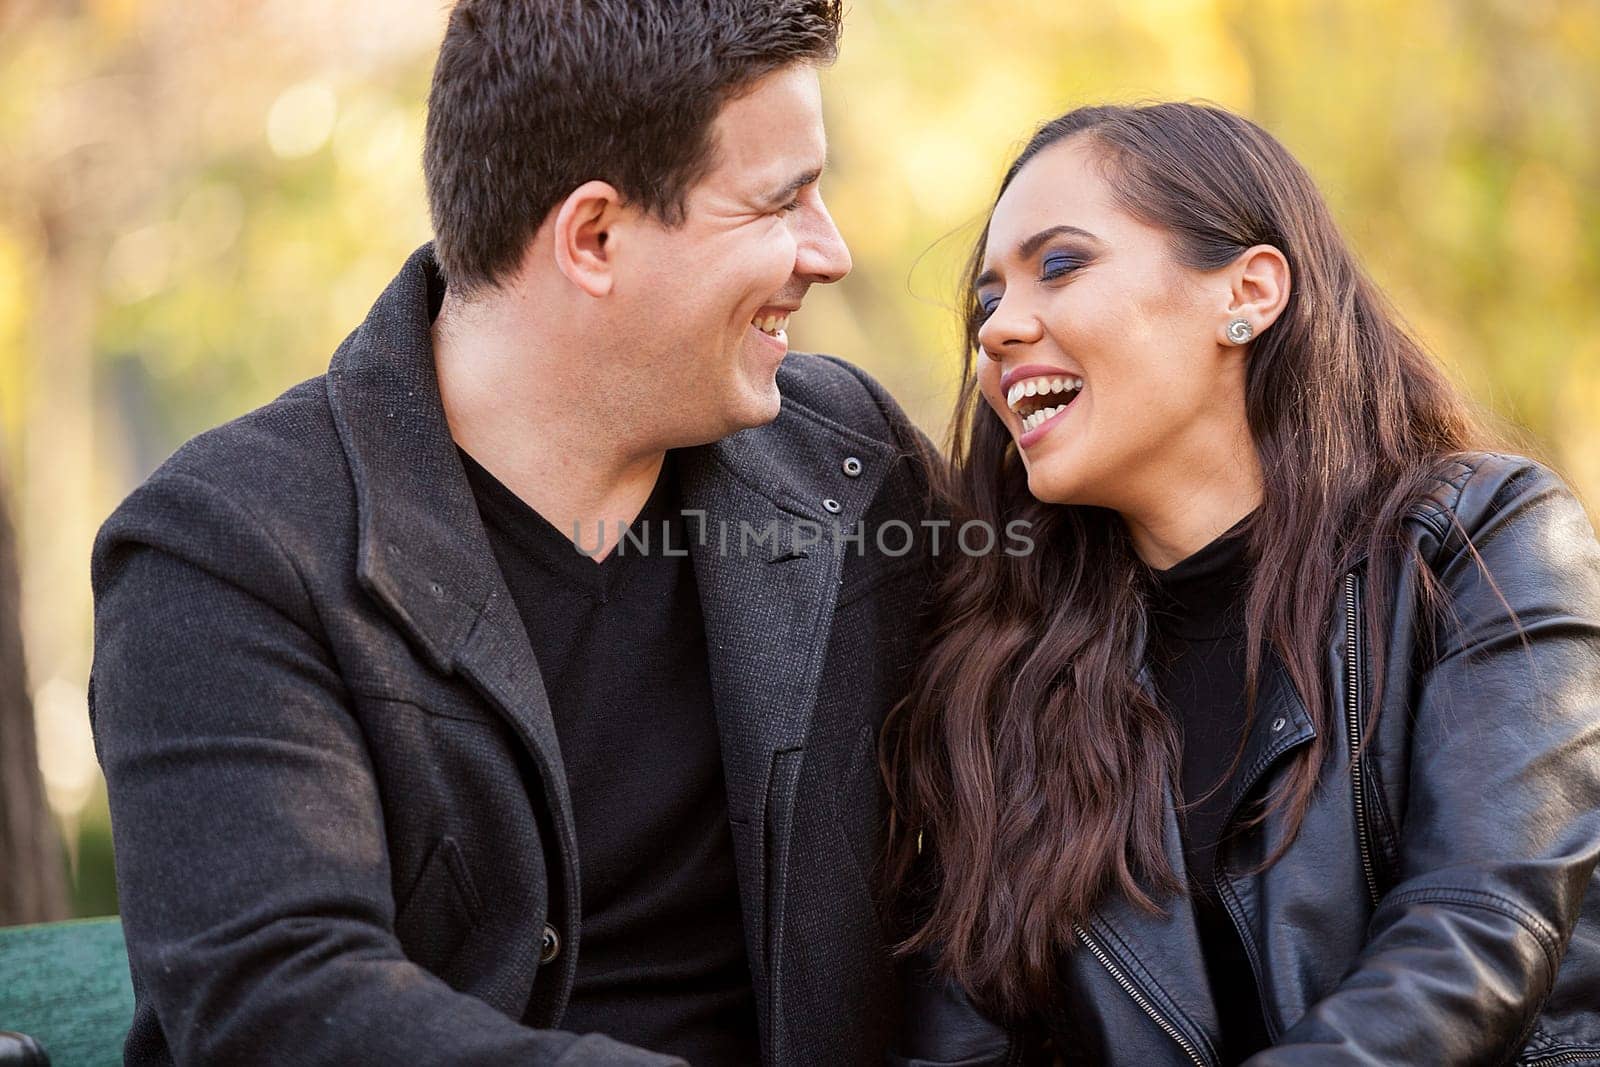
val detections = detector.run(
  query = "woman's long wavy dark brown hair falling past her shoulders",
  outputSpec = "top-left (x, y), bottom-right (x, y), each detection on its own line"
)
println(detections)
top-left (882, 104), bottom-right (1485, 1017)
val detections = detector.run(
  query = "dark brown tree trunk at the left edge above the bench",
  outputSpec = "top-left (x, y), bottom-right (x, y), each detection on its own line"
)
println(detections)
top-left (0, 459), bottom-right (67, 926)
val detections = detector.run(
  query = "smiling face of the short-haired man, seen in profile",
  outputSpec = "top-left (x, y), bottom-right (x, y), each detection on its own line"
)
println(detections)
top-left (611, 64), bottom-right (850, 448)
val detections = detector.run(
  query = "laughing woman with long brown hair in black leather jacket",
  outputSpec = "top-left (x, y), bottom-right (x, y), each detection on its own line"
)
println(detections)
top-left (885, 104), bottom-right (1600, 1067)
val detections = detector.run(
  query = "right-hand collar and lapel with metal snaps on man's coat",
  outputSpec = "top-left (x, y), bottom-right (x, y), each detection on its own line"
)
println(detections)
top-left (680, 391), bottom-right (893, 1003)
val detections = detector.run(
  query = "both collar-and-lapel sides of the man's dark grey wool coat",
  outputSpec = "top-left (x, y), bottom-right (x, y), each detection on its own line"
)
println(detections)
top-left (316, 245), bottom-right (893, 998)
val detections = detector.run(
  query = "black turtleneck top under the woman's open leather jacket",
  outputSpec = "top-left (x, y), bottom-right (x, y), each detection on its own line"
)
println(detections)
top-left (1150, 518), bottom-right (1269, 1064)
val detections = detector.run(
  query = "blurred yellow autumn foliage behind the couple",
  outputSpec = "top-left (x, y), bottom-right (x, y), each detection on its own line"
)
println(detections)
top-left (0, 0), bottom-right (1600, 913)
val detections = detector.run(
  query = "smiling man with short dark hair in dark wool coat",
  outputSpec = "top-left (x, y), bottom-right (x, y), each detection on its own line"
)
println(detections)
top-left (91, 0), bottom-right (928, 1064)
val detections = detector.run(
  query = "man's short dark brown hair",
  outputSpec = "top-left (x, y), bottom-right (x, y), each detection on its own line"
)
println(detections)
top-left (422, 0), bottom-right (842, 293)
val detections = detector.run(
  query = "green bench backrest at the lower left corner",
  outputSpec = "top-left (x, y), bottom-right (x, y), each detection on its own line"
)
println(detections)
top-left (0, 917), bottom-right (133, 1067)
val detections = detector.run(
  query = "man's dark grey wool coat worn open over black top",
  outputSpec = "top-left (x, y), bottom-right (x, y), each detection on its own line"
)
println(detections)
top-left (91, 248), bottom-right (930, 1065)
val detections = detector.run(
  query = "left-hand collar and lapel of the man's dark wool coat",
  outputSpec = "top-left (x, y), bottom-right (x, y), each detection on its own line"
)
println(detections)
top-left (326, 246), bottom-right (579, 991)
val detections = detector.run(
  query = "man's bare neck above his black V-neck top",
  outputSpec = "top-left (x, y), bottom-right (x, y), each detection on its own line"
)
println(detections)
top-left (432, 287), bottom-right (666, 561)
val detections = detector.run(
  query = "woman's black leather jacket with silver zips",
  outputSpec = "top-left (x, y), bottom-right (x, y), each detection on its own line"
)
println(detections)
top-left (896, 456), bottom-right (1600, 1067)
